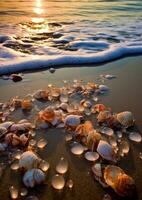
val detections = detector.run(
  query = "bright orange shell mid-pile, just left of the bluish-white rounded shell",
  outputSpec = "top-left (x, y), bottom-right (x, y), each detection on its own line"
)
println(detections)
top-left (39, 107), bottom-right (55, 123)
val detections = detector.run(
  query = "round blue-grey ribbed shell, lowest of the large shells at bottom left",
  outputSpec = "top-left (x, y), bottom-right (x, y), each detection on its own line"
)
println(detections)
top-left (23, 169), bottom-right (45, 188)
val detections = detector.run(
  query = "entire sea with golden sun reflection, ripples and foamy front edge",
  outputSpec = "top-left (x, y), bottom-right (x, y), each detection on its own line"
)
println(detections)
top-left (0, 0), bottom-right (142, 75)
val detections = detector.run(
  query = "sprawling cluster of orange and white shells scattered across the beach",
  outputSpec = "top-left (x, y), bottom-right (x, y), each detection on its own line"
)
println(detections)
top-left (0, 75), bottom-right (142, 199)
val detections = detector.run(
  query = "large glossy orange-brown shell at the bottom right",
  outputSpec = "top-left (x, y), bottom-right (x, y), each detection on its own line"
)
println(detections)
top-left (104, 165), bottom-right (135, 197)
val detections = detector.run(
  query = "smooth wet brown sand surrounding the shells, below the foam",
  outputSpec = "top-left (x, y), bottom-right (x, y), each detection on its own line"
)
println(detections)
top-left (0, 56), bottom-right (142, 200)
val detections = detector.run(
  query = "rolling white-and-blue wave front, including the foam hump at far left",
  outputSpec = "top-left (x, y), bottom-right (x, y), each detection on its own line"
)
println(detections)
top-left (0, 43), bottom-right (142, 75)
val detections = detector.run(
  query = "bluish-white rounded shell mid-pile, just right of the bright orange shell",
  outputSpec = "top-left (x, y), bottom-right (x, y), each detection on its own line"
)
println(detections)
top-left (64, 115), bottom-right (81, 126)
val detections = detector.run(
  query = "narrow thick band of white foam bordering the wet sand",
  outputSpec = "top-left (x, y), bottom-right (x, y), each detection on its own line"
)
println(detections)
top-left (0, 46), bottom-right (142, 75)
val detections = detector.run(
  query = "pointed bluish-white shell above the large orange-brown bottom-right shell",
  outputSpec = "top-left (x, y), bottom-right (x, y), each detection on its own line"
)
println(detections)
top-left (97, 140), bottom-right (115, 161)
